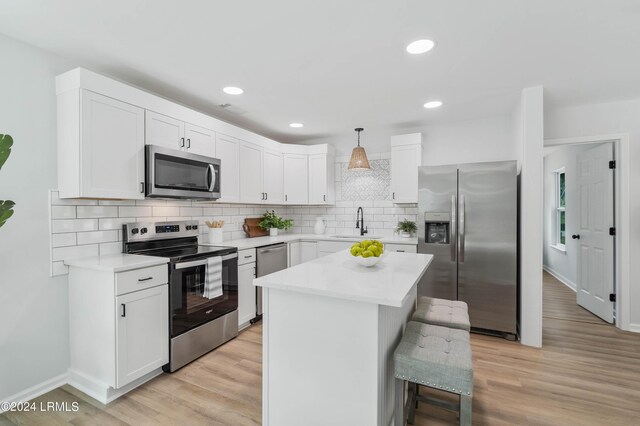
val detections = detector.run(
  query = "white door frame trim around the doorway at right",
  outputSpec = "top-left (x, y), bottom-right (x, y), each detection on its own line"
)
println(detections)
top-left (544, 133), bottom-right (640, 331)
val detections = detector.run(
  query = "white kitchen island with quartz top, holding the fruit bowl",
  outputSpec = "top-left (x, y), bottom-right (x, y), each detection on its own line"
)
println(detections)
top-left (254, 251), bottom-right (432, 426)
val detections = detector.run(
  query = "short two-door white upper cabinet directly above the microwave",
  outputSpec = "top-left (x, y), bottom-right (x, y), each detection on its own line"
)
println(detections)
top-left (145, 111), bottom-right (215, 157)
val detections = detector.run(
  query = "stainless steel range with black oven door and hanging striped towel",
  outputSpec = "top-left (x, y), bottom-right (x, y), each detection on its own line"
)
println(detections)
top-left (122, 221), bottom-right (238, 372)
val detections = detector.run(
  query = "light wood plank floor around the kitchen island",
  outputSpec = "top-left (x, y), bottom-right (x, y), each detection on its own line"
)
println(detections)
top-left (0, 276), bottom-right (640, 426)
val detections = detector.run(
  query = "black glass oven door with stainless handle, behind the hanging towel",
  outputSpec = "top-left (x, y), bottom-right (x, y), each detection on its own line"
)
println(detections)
top-left (169, 253), bottom-right (238, 337)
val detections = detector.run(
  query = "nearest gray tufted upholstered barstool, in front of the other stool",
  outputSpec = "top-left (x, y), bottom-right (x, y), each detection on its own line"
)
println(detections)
top-left (393, 321), bottom-right (473, 426)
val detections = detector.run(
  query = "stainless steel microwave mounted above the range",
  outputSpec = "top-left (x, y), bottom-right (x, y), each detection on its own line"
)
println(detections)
top-left (145, 145), bottom-right (221, 200)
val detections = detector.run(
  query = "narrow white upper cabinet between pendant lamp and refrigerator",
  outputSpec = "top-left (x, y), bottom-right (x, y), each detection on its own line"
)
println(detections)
top-left (391, 133), bottom-right (422, 204)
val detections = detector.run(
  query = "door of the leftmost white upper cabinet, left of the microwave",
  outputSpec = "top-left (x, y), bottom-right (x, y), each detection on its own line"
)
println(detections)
top-left (80, 90), bottom-right (144, 200)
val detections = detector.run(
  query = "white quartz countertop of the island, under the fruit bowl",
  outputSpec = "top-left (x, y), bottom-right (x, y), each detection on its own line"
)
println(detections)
top-left (253, 250), bottom-right (433, 307)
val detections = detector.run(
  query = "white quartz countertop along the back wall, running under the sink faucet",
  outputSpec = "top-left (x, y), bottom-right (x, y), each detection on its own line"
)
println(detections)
top-left (200, 234), bottom-right (418, 250)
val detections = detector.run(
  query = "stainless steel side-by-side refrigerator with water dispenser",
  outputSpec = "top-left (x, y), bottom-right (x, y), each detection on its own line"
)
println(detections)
top-left (418, 161), bottom-right (518, 338)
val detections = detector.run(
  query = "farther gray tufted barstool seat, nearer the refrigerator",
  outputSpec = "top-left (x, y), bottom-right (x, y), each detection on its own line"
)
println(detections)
top-left (411, 296), bottom-right (471, 331)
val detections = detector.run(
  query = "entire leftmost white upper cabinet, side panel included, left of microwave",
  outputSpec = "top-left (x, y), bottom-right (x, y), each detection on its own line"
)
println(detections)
top-left (58, 89), bottom-right (144, 200)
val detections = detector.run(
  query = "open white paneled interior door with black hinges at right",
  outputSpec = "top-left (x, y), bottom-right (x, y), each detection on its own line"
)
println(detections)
top-left (572, 143), bottom-right (615, 323)
